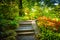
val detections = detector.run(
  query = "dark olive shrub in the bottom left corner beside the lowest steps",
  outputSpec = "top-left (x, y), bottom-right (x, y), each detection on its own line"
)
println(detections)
top-left (0, 30), bottom-right (16, 40)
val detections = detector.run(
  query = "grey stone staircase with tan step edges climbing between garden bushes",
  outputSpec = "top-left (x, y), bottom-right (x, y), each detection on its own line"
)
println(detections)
top-left (16, 20), bottom-right (36, 40)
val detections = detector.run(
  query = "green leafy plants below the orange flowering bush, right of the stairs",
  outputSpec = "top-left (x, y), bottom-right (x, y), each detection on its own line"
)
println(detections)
top-left (37, 26), bottom-right (60, 40)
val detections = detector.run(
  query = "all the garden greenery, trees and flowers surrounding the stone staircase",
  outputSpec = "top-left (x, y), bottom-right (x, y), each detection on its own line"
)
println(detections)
top-left (0, 0), bottom-right (60, 40)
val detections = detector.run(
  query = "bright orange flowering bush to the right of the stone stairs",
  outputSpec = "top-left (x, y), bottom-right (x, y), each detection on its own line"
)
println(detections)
top-left (37, 16), bottom-right (60, 31)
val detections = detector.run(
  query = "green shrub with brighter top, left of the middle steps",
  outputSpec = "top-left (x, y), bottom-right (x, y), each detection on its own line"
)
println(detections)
top-left (0, 19), bottom-right (18, 31)
